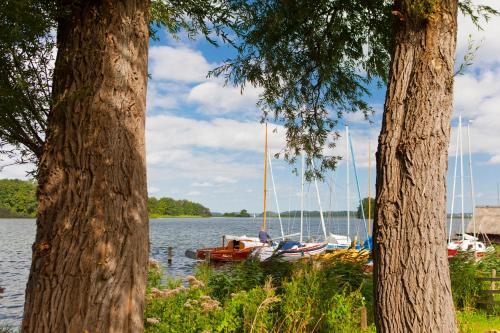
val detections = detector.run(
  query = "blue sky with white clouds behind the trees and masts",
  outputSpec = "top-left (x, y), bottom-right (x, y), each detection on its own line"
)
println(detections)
top-left (0, 0), bottom-right (500, 212)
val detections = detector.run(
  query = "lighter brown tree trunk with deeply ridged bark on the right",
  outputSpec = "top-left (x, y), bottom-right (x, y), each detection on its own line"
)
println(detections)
top-left (374, 0), bottom-right (457, 333)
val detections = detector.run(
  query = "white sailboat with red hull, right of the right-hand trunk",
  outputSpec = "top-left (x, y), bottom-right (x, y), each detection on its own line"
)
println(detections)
top-left (447, 115), bottom-right (494, 257)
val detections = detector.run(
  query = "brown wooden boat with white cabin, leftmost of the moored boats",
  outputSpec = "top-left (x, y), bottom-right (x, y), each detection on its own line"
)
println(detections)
top-left (196, 236), bottom-right (264, 262)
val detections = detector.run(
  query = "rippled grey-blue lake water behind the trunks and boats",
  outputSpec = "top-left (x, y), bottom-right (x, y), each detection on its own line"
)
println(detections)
top-left (0, 214), bottom-right (466, 326)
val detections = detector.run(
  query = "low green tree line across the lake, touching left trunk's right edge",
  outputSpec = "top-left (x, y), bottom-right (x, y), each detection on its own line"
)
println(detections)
top-left (148, 197), bottom-right (212, 217)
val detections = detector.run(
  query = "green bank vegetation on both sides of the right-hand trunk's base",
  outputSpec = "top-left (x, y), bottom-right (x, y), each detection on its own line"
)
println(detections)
top-left (145, 249), bottom-right (500, 333)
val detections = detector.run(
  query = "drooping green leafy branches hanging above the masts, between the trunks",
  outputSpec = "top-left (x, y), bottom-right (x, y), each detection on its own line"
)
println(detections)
top-left (211, 0), bottom-right (392, 175)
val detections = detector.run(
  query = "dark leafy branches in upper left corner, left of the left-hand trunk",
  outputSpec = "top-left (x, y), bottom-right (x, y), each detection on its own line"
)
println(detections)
top-left (0, 0), bottom-right (56, 163)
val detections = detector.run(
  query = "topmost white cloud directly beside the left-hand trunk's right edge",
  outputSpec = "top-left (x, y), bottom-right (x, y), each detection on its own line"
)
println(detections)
top-left (149, 46), bottom-right (211, 82)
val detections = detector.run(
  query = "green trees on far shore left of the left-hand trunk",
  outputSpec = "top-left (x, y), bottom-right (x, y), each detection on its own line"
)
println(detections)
top-left (0, 179), bottom-right (37, 217)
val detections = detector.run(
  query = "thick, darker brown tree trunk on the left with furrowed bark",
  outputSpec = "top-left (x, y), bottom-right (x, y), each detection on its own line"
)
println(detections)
top-left (22, 0), bottom-right (149, 333)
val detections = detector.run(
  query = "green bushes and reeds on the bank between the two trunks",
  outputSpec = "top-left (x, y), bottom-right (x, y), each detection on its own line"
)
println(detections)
top-left (145, 261), bottom-right (372, 332)
